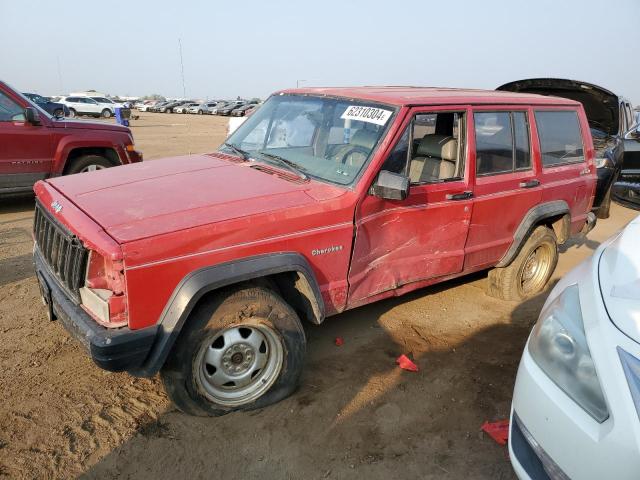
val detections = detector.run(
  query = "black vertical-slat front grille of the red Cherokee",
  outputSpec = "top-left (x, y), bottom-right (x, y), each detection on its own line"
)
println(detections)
top-left (33, 201), bottom-right (89, 302)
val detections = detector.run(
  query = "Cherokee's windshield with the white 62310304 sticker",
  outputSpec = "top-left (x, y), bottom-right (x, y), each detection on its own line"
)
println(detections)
top-left (222, 95), bottom-right (395, 185)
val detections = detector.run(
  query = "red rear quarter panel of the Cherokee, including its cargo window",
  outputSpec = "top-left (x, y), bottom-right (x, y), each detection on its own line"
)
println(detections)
top-left (534, 107), bottom-right (596, 234)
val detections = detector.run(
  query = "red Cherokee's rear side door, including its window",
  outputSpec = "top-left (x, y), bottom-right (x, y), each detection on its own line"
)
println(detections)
top-left (464, 107), bottom-right (542, 270)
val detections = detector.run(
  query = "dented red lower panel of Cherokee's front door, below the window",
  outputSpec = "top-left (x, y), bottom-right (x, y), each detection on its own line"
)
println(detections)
top-left (349, 187), bottom-right (471, 306)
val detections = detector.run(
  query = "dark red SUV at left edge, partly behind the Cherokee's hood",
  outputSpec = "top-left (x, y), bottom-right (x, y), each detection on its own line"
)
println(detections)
top-left (0, 82), bottom-right (142, 196)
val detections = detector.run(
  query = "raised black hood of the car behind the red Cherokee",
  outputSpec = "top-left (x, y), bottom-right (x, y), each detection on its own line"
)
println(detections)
top-left (496, 78), bottom-right (620, 135)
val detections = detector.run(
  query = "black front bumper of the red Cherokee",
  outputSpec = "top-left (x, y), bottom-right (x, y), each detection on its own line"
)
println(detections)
top-left (33, 248), bottom-right (158, 372)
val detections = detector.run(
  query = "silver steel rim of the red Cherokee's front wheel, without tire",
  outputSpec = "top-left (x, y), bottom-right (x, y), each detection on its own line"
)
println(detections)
top-left (195, 324), bottom-right (284, 407)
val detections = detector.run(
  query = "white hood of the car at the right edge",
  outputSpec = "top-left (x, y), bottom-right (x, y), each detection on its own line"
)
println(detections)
top-left (598, 217), bottom-right (640, 343)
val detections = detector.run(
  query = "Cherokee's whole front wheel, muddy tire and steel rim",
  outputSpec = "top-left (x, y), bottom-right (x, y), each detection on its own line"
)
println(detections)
top-left (160, 288), bottom-right (306, 416)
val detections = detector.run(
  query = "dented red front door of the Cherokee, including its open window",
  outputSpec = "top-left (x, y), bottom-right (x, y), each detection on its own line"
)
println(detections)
top-left (348, 106), bottom-right (473, 307)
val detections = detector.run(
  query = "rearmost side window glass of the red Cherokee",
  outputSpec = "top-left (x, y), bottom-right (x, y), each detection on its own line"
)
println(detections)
top-left (535, 110), bottom-right (584, 167)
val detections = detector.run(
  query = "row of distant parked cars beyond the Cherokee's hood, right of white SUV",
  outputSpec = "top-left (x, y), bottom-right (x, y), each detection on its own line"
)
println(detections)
top-left (136, 100), bottom-right (258, 117)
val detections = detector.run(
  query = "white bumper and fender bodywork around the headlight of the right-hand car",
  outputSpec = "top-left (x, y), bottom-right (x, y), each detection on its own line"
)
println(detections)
top-left (509, 253), bottom-right (640, 480)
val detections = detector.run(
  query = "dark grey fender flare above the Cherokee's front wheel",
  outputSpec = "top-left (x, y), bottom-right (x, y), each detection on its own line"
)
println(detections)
top-left (129, 253), bottom-right (325, 377)
